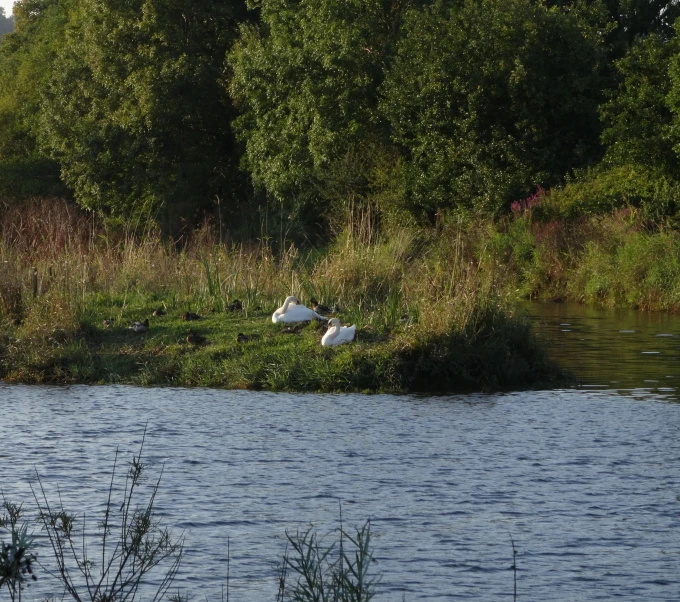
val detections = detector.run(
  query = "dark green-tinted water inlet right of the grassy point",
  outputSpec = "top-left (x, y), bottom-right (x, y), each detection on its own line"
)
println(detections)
top-left (523, 303), bottom-right (680, 399)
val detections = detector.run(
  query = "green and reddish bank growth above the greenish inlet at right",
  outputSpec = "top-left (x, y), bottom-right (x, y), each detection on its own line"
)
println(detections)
top-left (490, 201), bottom-right (680, 311)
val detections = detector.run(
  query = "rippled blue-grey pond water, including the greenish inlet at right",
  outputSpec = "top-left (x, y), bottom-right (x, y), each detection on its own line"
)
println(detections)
top-left (0, 306), bottom-right (680, 602)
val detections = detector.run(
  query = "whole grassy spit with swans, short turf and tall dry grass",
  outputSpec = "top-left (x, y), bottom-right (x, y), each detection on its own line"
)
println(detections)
top-left (0, 201), bottom-right (559, 392)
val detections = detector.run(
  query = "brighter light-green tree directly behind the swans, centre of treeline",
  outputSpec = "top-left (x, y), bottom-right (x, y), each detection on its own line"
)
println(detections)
top-left (229, 0), bottom-right (420, 239)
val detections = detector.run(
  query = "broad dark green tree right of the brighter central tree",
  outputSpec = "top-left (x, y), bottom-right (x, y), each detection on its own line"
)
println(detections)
top-left (382, 0), bottom-right (601, 219)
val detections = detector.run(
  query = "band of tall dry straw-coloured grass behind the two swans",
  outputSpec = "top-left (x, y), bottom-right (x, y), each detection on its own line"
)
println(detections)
top-left (0, 200), bottom-right (502, 332)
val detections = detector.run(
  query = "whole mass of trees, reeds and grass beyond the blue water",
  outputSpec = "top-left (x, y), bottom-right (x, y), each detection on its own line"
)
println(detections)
top-left (0, 0), bottom-right (680, 390)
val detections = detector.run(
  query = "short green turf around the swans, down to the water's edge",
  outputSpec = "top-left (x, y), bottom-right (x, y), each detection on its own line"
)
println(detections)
top-left (0, 297), bottom-right (559, 392)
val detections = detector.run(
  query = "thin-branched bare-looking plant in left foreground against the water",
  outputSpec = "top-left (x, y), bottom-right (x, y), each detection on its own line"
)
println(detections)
top-left (33, 428), bottom-right (183, 602)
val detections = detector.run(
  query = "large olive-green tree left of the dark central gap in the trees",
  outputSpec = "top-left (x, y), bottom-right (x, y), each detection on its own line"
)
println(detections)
top-left (41, 0), bottom-right (245, 228)
